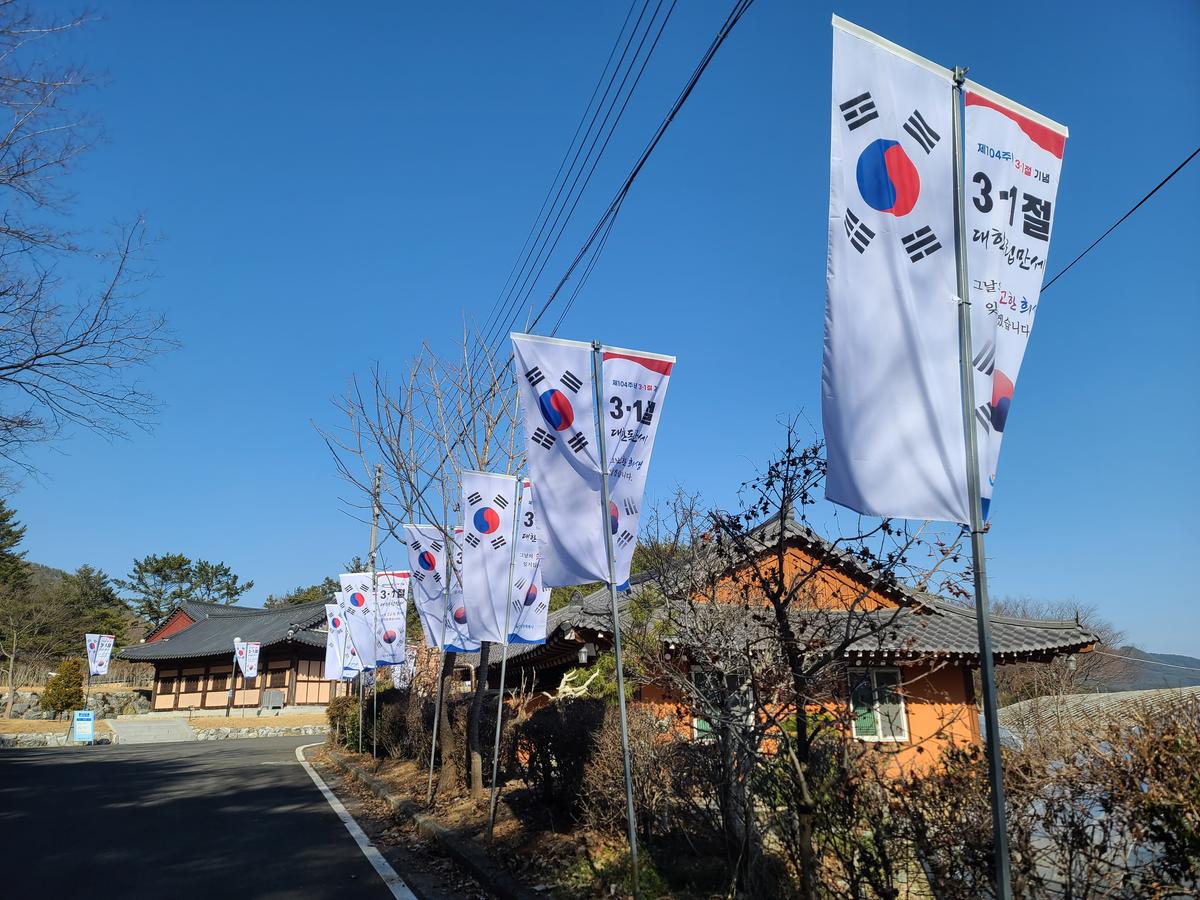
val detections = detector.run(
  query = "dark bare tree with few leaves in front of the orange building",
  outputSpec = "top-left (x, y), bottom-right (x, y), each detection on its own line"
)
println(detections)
top-left (626, 424), bottom-right (966, 898)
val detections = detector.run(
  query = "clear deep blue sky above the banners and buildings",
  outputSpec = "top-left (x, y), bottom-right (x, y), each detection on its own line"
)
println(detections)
top-left (12, 0), bottom-right (1200, 655)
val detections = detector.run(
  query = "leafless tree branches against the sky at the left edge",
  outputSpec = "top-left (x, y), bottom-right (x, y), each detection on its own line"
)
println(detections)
top-left (0, 0), bottom-right (174, 487)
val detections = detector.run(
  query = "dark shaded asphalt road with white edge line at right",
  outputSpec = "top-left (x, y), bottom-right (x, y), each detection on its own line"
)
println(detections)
top-left (0, 737), bottom-right (403, 900)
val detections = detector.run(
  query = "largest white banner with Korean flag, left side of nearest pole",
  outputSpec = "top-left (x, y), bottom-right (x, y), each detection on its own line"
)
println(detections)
top-left (821, 17), bottom-right (970, 522)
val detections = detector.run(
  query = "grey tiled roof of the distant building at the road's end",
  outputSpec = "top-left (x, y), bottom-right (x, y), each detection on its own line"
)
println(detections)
top-left (116, 600), bottom-right (325, 662)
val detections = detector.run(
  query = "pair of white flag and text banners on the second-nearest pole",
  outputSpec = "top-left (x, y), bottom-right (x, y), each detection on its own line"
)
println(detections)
top-left (512, 334), bottom-right (676, 587)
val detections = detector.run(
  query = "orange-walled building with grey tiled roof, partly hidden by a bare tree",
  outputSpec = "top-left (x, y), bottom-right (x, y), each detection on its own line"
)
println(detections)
top-left (470, 518), bottom-right (1096, 768)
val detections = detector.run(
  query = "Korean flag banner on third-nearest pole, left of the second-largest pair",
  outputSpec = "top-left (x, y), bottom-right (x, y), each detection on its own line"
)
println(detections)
top-left (462, 472), bottom-right (518, 643)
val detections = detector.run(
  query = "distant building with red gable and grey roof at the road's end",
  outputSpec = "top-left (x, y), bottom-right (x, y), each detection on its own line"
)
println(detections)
top-left (116, 600), bottom-right (344, 712)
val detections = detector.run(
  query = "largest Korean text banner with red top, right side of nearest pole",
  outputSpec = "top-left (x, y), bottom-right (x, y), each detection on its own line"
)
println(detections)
top-left (964, 82), bottom-right (1067, 517)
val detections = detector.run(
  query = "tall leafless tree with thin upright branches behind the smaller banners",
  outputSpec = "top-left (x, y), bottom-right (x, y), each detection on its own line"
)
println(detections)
top-left (322, 324), bottom-right (523, 796)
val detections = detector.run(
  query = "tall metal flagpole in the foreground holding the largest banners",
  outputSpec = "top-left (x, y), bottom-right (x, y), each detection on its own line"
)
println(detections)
top-left (953, 67), bottom-right (1013, 900)
